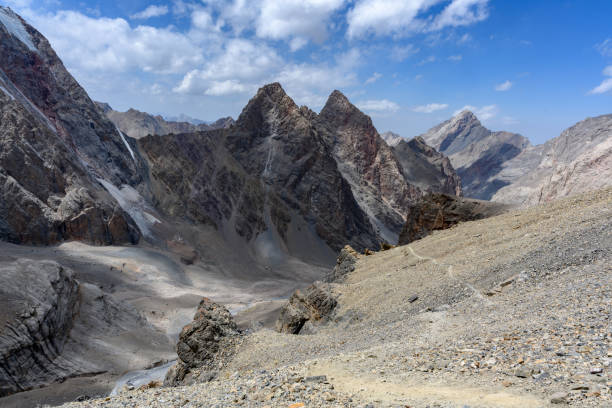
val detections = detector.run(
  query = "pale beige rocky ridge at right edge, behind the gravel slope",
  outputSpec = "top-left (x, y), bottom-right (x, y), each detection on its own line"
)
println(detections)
top-left (492, 115), bottom-right (612, 205)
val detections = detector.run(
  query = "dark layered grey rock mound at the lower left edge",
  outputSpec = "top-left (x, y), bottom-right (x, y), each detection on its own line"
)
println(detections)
top-left (0, 261), bottom-right (79, 397)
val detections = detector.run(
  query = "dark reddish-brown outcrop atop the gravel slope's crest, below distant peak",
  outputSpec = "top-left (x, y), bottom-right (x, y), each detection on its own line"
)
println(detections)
top-left (399, 193), bottom-right (508, 245)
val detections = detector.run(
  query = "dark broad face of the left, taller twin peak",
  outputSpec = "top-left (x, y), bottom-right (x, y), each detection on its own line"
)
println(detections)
top-left (139, 84), bottom-right (378, 250)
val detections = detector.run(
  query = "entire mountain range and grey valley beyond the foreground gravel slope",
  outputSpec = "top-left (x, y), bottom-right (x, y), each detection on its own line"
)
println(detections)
top-left (0, 7), bottom-right (612, 406)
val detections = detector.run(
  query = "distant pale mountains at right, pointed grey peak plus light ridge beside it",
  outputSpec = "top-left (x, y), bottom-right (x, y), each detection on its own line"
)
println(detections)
top-left (422, 111), bottom-right (612, 205)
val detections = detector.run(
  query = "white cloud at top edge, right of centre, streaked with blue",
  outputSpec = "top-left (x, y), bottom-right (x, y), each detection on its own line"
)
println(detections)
top-left (347, 0), bottom-right (488, 38)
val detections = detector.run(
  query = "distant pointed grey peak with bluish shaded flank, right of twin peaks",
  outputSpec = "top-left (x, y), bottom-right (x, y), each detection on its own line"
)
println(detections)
top-left (421, 111), bottom-right (530, 200)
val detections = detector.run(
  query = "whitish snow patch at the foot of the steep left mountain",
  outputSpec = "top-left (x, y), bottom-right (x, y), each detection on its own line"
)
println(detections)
top-left (97, 178), bottom-right (161, 237)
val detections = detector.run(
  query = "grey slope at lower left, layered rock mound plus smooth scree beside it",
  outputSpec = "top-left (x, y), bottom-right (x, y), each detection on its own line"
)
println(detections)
top-left (0, 255), bottom-right (171, 400)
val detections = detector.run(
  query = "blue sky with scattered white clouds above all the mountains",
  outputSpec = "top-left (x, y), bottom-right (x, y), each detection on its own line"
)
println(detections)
top-left (7, 0), bottom-right (612, 143)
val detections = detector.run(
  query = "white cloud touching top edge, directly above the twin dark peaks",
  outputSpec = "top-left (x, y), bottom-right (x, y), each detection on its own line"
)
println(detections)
top-left (255, 0), bottom-right (345, 48)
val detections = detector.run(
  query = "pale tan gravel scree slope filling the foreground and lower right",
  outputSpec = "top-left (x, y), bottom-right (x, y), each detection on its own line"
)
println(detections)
top-left (61, 189), bottom-right (612, 408)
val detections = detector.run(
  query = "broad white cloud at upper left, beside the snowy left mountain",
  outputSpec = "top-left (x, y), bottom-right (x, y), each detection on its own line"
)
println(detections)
top-left (29, 11), bottom-right (203, 73)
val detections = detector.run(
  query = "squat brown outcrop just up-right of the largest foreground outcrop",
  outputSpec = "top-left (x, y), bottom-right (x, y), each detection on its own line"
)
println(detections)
top-left (276, 282), bottom-right (338, 334)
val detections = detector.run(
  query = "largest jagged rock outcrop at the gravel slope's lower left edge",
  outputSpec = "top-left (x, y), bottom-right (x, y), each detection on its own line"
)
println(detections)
top-left (165, 298), bottom-right (239, 385)
